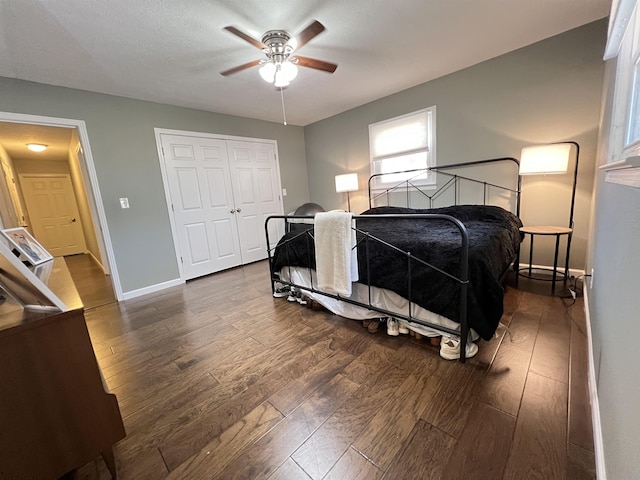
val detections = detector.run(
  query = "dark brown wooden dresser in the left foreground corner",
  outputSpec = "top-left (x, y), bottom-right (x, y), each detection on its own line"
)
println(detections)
top-left (0, 258), bottom-right (125, 480)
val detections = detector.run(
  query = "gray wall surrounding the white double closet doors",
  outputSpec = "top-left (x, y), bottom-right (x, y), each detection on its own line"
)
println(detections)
top-left (0, 77), bottom-right (309, 292)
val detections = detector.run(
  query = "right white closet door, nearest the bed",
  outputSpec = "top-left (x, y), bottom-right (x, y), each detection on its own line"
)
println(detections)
top-left (227, 140), bottom-right (282, 263)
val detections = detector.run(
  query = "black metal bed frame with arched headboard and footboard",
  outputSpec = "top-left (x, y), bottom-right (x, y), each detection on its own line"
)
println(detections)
top-left (265, 157), bottom-right (520, 363)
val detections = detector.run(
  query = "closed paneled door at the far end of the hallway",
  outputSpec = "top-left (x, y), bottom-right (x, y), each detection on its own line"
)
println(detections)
top-left (19, 174), bottom-right (87, 257)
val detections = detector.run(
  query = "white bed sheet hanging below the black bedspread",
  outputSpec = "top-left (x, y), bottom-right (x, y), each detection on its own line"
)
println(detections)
top-left (279, 267), bottom-right (479, 341)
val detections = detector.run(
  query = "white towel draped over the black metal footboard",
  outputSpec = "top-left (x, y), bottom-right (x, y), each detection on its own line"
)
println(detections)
top-left (315, 211), bottom-right (358, 296)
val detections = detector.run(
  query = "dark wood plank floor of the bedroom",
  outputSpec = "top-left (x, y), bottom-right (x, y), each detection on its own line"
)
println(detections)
top-left (65, 262), bottom-right (595, 480)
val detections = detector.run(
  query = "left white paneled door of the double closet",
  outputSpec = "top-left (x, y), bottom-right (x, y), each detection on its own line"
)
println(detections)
top-left (161, 134), bottom-right (242, 280)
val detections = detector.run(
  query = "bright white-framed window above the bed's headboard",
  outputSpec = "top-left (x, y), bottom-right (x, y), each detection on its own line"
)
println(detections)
top-left (369, 106), bottom-right (436, 190)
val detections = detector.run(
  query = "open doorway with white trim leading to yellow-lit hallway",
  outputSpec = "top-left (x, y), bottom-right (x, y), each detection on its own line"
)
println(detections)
top-left (0, 112), bottom-right (123, 306)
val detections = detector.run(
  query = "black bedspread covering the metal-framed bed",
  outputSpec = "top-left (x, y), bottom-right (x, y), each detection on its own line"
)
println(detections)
top-left (273, 205), bottom-right (522, 340)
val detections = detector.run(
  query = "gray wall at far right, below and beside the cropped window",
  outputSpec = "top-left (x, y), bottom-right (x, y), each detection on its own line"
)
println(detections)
top-left (587, 56), bottom-right (640, 480)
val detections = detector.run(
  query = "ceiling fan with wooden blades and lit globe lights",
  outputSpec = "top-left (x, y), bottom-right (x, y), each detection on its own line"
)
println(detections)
top-left (220, 20), bottom-right (338, 87)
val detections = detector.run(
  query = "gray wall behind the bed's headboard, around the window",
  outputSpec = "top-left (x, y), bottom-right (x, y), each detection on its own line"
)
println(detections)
top-left (305, 20), bottom-right (607, 269)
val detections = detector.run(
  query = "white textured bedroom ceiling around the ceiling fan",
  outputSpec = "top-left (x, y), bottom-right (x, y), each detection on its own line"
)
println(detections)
top-left (0, 0), bottom-right (610, 125)
